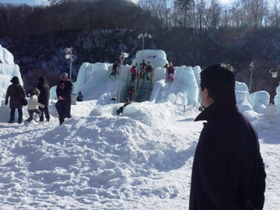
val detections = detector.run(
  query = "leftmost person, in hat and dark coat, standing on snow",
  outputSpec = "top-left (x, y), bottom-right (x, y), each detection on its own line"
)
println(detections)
top-left (5, 76), bottom-right (26, 124)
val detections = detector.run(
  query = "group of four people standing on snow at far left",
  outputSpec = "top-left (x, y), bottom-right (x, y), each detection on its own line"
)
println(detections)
top-left (5, 73), bottom-right (73, 125)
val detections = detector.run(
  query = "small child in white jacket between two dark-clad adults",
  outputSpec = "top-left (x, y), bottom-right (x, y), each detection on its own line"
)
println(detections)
top-left (26, 88), bottom-right (45, 122)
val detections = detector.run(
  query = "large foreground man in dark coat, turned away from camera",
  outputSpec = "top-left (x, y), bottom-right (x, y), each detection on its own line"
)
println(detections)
top-left (189, 64), bottom-right (266, 210)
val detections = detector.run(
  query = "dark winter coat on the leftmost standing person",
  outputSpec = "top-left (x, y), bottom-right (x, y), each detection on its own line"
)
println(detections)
top-left (5, 83), bottom-right (26, 108)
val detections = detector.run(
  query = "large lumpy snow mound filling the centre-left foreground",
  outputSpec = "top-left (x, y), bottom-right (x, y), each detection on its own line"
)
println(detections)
top-left (1, 110), bottom-right (190, 209)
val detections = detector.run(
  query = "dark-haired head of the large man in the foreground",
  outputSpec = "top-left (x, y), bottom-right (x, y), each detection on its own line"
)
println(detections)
top-left (200, 63), bottom-right (235, 101)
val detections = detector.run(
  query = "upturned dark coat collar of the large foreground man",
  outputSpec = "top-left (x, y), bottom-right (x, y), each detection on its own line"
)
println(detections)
top-left (194, 95), bottom-right (237, 121)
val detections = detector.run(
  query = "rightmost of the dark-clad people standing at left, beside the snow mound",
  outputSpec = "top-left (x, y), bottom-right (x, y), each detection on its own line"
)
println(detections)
top-left (56, 73), bottom-right (73, 125)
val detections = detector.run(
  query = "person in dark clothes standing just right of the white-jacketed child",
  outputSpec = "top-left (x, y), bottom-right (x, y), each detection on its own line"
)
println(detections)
top-left (37, 76), bottom-right (50, 122)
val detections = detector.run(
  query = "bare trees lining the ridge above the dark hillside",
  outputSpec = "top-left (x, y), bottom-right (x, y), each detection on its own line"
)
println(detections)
top-left (0, 0), bottom-right (280, 36)
